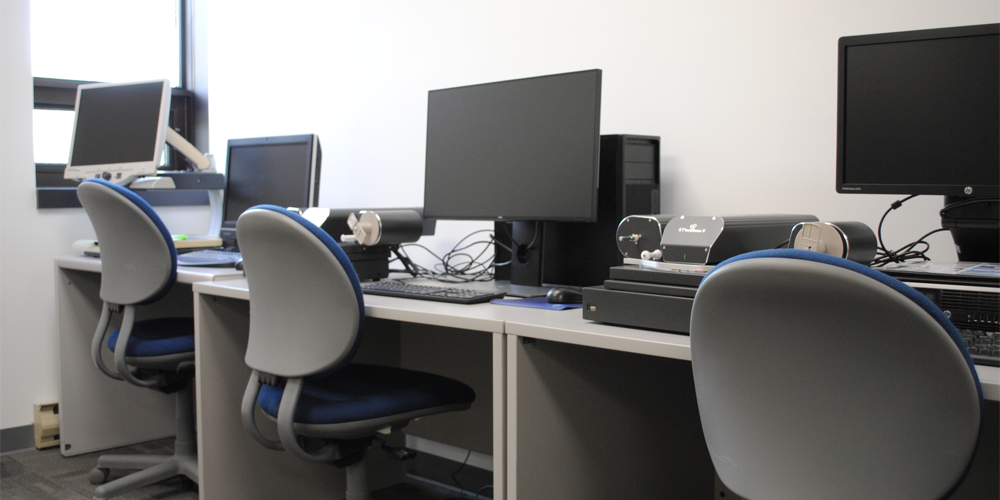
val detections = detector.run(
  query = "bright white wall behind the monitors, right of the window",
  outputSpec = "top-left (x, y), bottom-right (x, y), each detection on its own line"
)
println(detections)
top-left (209, 0), bottom-right (1000, 259)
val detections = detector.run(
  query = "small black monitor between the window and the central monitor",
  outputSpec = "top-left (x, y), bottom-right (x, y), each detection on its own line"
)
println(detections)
top-left (220, 134), bottom-right (322, 246)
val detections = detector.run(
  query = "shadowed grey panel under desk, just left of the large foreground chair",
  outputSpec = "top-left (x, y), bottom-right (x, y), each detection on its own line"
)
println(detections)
top-left (507, 335), bottom-right (714, 500)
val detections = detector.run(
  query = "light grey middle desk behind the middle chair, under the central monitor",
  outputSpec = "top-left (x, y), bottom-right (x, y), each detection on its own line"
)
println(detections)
top-left (193, 280), bottom-right (559, 499)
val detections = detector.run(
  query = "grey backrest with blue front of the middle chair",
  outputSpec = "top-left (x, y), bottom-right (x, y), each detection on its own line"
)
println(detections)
top-left (236, 205), bottom-right (364, 377)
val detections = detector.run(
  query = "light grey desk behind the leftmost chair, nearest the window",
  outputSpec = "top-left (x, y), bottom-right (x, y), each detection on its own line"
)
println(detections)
top-left (56, 256), bottom-right (243, 456)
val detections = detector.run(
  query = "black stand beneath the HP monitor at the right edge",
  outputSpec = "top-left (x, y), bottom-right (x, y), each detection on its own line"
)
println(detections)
top-left (941, 196), bottom-right (1000, 262)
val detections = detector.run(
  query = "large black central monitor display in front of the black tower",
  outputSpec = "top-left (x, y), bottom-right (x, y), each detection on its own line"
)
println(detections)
top-left (424, 70), bottom-right (601, 222)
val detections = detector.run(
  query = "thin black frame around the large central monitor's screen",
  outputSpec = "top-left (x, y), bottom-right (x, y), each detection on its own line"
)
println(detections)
top-left (424, 68), bottom-right (603, 222)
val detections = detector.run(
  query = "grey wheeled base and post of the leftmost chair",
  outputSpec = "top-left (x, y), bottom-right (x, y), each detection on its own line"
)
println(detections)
top-left (89, 379), bottom-right (198, 499)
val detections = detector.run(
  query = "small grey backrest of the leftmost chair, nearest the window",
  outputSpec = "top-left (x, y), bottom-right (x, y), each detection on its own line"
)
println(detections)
top-left (76, 179), bottom-right (177, 305)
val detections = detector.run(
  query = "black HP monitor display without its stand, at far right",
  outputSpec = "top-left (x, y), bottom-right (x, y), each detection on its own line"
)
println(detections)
top-left (837, 24), bottom-right (1000, 196)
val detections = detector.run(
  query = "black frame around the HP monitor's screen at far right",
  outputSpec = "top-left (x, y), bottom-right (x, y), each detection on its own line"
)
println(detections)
top-left (836, 24), bottom-right (1000, 196)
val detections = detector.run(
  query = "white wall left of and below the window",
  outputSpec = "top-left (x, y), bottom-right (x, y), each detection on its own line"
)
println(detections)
top-left (0, 0), bottom-right (208, 430)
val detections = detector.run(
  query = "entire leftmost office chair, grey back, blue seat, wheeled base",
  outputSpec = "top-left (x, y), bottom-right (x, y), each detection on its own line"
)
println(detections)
top-left (77, 179), bottom-right (198, 498)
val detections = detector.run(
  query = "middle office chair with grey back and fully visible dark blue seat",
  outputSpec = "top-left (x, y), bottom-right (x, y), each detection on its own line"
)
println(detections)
top-left (236, 205), bottom-right (476, 500)
